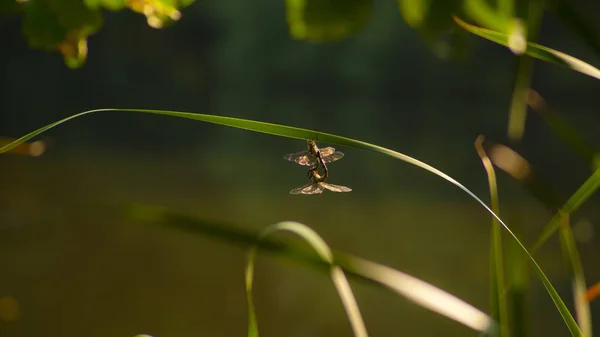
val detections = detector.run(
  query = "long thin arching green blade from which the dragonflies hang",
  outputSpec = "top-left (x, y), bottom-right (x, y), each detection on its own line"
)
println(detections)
top-left (0, 109), bottom-right (581, 336)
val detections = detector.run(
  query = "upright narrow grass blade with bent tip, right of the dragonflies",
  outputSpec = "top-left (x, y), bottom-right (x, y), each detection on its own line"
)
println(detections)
top-left (475, 136), bottom-right (510, 337)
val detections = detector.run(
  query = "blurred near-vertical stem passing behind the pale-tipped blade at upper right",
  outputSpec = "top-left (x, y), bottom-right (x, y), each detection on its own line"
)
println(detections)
top-left (508, 0), bottom-right (544, 141)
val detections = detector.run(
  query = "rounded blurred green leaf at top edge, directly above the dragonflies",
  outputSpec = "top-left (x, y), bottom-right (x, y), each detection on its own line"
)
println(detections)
top-left (286, 0), bottom-right (373, 42)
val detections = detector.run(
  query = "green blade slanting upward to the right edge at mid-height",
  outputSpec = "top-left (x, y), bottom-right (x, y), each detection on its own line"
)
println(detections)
top-left (531, 168), bottom-right (600, 253)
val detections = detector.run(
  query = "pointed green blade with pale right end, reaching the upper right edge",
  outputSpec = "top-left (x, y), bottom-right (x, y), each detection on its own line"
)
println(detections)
top-left (454, 16), bottom-right (600, 79)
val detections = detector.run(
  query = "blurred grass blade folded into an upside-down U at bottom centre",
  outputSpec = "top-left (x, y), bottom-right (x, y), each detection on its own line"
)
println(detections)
top-left (246, 221), bottom-right (369, 337)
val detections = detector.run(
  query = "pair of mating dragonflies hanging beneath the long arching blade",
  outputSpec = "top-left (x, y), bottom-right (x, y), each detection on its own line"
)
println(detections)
top-left (283, 140), bottom-right (352, 194)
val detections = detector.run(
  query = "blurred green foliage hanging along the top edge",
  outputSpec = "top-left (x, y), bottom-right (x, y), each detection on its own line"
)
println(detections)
top-left (0, 0), bottom-right (599, 68)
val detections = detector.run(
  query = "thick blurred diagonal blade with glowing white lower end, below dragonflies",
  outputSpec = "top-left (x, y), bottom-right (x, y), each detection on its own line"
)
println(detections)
top-left (126, 205), bottom-right (496, 334)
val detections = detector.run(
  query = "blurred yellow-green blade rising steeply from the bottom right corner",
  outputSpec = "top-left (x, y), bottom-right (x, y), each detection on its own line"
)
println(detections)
top-left (560, 214), bottom-right (593, 336)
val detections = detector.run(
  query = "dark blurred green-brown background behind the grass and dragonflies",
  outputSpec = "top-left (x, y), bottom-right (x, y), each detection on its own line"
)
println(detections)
top-left (0, 0), bottom-right (600, 337)
